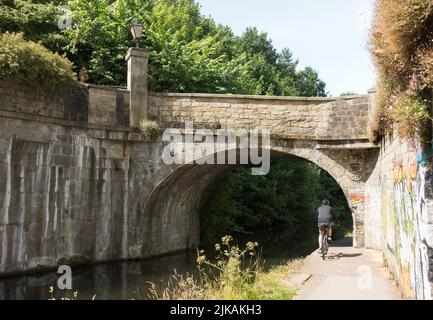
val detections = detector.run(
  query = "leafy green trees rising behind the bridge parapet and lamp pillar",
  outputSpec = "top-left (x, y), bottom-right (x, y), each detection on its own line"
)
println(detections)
top-left (0, 0), bottom-right (326, 96)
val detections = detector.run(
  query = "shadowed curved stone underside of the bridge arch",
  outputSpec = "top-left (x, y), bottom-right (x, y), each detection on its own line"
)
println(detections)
top-left (142, 151), bottom-right (356, 256)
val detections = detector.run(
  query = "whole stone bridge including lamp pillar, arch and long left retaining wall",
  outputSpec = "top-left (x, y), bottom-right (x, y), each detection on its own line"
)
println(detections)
top-left (0, 49), bottom-right (430, 300)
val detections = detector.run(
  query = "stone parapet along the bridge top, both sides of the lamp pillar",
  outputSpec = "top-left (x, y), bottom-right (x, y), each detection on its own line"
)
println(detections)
top-left (0, 82), bottom-right (369, 140)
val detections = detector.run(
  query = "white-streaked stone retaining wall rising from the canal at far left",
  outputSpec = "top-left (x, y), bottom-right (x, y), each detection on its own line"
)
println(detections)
top-left (0, 119), bottom-right (127, 273)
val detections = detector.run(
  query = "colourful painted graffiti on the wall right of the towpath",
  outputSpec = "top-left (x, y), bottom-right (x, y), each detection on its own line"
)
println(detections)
top-left (382, 148), bottom-right (431, 299)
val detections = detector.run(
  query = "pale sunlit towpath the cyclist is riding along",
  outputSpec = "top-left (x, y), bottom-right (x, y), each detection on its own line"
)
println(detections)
top-left (290, 238), bottom-right (401, 300)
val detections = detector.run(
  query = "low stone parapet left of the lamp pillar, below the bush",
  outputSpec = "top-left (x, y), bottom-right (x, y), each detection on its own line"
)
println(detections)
top-left (0, 81), bottom-right (129, 127)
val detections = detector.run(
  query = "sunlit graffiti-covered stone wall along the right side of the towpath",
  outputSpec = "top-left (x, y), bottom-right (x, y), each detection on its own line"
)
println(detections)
top-left (366, 137), bottom-right (433, 299)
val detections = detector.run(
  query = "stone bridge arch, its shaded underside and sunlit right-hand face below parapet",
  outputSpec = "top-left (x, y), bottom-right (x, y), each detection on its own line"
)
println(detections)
top-left (137, 139), bottom-right (369, 256)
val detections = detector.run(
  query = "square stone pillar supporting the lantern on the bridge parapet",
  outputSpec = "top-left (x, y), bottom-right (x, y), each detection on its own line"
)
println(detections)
top-left (125, 48), bottom-right (149, 127)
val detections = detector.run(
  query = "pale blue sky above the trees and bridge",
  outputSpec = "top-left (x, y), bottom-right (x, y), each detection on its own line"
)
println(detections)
top-left (197, 0), bottom-right (376, 96)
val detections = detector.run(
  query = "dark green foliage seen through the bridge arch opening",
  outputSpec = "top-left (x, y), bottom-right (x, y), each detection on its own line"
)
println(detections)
top-left (201, 158), bottom-right (352, 245)
